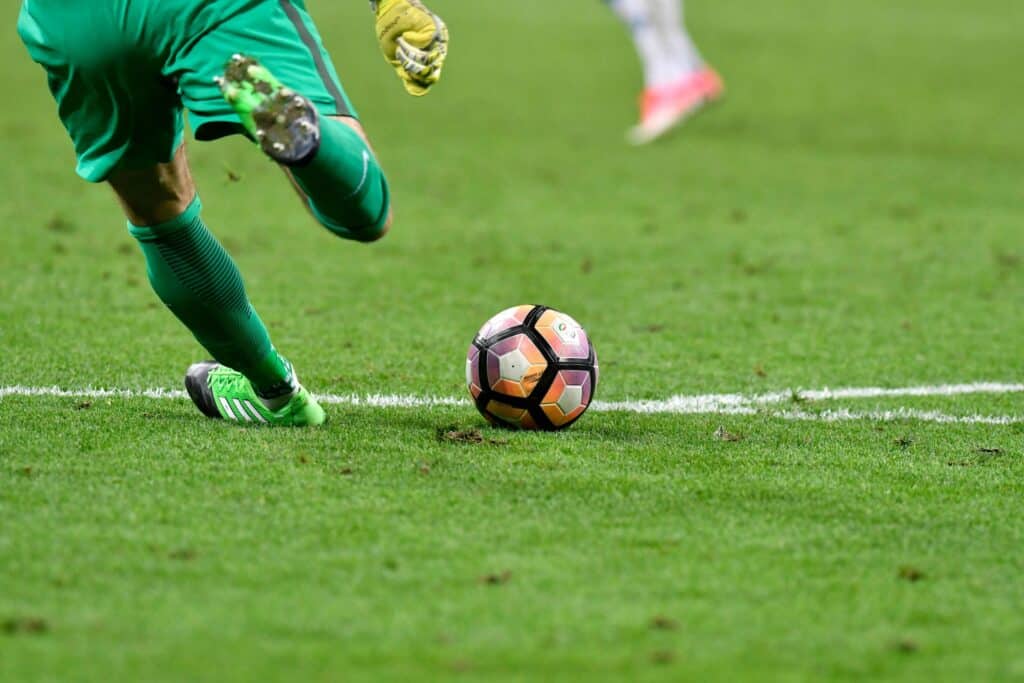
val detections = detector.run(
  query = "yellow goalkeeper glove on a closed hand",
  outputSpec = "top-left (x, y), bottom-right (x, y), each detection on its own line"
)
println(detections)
top-left (370, 0), bottom-right (447, 96)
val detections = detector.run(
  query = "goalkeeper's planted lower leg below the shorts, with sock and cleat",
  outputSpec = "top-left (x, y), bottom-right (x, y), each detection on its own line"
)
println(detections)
top-left (108, 145), bottom-right (324, 425)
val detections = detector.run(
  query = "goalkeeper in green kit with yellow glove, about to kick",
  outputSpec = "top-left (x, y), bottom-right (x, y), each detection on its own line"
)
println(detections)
top-left (17, 0), bottom-right (447, 426)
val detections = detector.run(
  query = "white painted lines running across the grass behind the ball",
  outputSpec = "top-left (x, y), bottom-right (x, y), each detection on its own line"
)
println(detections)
top-left (0, 382), bottom-right (1024, 425)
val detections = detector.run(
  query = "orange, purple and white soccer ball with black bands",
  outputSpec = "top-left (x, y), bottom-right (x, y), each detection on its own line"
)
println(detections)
top-left (466, 305), bottom-right (598, 430)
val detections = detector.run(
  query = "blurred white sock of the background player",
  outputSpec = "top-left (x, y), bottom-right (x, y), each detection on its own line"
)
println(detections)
top-left (608, 0), bottom-right (690, 88)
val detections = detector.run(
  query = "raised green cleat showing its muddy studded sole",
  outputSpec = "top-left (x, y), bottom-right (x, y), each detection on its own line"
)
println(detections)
top-left (216, 54), bottom-right (321, 166)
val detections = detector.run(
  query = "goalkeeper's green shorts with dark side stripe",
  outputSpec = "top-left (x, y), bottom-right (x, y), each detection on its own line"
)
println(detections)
top-left (17, 0), bottom-right (355, 182)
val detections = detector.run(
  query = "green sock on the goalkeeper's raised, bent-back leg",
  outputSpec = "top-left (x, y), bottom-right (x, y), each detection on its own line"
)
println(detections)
top-left (291, 117), bottom-right (390, 242)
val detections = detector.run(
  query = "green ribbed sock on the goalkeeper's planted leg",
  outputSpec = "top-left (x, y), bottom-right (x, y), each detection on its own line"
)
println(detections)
top-left (128, 197), bottom-right (294, 396)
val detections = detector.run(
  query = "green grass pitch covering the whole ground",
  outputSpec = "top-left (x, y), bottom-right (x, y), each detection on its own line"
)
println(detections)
top-left (0, 0), bottom-right (1024, 682)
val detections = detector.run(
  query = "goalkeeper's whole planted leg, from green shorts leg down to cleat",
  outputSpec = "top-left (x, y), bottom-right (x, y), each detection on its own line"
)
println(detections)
top-left (17, 0), bottom-right (324, 424)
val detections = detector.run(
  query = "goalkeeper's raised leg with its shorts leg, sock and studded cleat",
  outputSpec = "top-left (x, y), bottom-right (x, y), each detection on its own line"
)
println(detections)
top-left (170, 0), bottom-right (391, 242)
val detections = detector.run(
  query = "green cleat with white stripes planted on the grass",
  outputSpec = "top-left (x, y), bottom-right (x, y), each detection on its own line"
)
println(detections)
top-left (185, 360), bottom-right (326, 427)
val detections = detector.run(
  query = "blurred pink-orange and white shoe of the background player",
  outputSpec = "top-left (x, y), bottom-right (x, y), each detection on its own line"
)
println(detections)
top-left (627, 67), bottom-right (725, 144)
